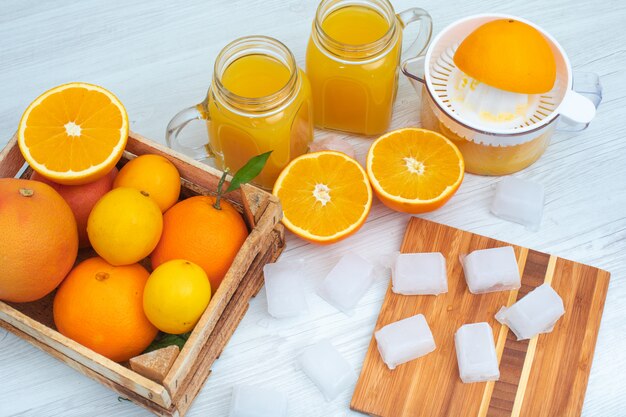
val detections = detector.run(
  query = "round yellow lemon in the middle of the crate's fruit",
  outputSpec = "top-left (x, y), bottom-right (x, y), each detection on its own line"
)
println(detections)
top-left (87, 187), bottom-right (163, 266)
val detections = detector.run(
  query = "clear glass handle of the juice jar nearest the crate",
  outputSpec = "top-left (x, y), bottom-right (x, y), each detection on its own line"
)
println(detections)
top-left (165, 100), bottom-right (214, 161)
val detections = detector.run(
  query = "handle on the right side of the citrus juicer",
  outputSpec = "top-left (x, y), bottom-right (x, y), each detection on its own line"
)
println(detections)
top-left (557, 72), bottom-right (602, 132)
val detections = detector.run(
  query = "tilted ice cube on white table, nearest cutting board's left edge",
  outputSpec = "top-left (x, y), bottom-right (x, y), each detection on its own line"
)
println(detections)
top-left (318, 253), bottom-right (374, 314)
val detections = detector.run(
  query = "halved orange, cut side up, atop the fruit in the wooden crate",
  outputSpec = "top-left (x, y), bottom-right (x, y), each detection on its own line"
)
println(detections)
top-left (17, 83), bottom-right (128, 185)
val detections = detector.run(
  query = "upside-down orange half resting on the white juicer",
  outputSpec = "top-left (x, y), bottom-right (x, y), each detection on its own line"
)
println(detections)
top-left (454, 19), bottom-right (556, 94)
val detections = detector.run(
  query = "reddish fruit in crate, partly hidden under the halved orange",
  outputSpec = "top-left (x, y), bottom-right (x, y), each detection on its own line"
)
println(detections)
top-left (31, 168), bottom-right (117, 248)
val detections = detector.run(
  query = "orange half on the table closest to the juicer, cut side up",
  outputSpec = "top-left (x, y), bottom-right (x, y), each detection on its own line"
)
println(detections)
top-left (367, 128), bottom-right (465, 214)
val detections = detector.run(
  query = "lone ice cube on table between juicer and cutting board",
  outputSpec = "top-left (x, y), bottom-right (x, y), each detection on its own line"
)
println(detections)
top-left (491, 177), bottom-right (544, 230)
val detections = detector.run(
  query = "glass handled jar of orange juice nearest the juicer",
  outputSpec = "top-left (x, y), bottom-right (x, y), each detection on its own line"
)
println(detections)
top-left (306, 0), bottom-right (432, 135)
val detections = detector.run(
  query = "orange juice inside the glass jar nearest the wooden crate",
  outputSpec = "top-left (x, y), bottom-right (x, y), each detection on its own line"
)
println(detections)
top-left (206, 50), bottom-right (313, 189)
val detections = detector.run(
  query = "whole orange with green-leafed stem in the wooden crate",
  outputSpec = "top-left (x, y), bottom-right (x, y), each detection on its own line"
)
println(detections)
top-left (151, 196), bottom-right (248, 293)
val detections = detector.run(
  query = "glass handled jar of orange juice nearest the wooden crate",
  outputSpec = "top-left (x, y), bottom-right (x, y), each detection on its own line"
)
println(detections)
top-left (166, 36), bottom-right (313, 189)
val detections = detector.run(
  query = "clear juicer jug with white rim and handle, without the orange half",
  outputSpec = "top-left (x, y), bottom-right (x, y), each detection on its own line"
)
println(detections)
top-left (402, 14), bottom-right (602, 175)
